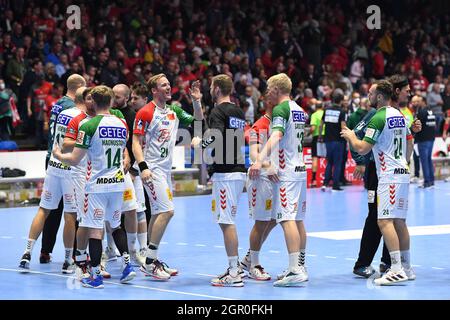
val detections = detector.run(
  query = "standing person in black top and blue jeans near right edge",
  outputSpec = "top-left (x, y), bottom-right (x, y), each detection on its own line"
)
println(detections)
top-left (415, 94), bottom-right (438, 188)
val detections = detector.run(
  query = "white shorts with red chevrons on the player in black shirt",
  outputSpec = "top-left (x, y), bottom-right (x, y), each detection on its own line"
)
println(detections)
top-left (211, 172), bottom-right (246, 224)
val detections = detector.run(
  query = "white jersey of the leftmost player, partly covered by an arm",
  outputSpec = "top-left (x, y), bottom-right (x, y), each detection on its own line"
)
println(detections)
top-left (47, 108), bottom-right (82, 177)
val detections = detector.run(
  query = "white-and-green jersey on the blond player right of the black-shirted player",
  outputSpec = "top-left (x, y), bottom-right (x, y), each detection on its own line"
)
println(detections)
top-left (271, 101), bottom-right (307, 181)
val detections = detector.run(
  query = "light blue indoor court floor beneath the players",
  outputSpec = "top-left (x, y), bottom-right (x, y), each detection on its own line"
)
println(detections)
top-left (0, 182), bottom-right (450, 300)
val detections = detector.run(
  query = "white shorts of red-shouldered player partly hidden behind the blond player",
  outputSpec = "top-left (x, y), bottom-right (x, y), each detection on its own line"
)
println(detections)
top-left (247, 176), bottom-right (275, 221)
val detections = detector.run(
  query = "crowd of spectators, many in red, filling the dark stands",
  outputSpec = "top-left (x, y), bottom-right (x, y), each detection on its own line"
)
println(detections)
top-left (0, 0), bottom-right (450, 165)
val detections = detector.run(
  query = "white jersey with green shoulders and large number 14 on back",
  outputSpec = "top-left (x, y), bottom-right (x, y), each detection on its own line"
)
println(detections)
top-left (75, 114), bottom-right (128, 193)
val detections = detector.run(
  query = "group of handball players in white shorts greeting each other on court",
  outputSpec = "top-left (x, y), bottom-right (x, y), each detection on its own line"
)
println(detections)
top-left (19, 73), bottom-right (415, 288)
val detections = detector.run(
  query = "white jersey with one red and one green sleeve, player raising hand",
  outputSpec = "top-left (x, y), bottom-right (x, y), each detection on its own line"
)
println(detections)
top-left (133, 102), bottom-right (194, 171)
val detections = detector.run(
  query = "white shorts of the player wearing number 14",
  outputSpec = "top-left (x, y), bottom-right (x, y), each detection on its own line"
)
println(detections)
top-left (79, 192), bottom-right (123, 229)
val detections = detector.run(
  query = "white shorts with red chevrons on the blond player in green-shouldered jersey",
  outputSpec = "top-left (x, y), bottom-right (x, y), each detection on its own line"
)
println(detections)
top-left (273, 180), bottom-right (306, 223)
